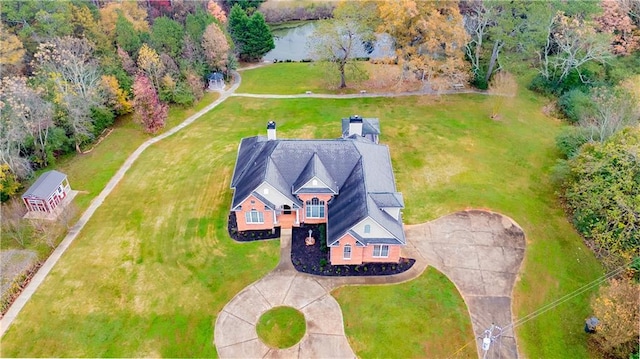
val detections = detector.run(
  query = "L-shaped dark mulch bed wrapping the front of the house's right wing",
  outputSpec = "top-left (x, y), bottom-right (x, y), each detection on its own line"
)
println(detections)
top-left (291, 224), bottom-right (416, 277)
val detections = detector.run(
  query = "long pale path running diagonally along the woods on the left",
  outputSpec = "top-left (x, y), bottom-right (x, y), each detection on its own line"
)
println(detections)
top-left (0, 74), bottom-right (241, 338)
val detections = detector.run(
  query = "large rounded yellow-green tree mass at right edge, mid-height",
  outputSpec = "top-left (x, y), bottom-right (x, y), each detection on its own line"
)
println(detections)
top-left (564, 128), bottom-right (640, 266)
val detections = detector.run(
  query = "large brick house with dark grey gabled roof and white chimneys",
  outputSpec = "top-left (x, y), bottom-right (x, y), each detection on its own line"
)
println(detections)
top-left (231, 116), bottom-right (405, 265)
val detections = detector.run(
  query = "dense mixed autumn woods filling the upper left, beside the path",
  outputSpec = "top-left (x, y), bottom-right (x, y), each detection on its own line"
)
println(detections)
top-left (0, 0), bottom-right (273, 201)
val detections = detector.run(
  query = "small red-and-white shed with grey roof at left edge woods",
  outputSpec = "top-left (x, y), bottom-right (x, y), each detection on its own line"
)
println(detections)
top-left (22, 170), bottom-right (71, 213)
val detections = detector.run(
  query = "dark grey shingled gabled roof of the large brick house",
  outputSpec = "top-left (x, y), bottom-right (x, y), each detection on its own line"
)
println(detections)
top-left (231, 136), bottom-right (405, 245)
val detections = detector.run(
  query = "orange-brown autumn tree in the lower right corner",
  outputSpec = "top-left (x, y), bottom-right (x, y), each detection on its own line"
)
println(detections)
top-left (591, 278), bottom-right (640, 359)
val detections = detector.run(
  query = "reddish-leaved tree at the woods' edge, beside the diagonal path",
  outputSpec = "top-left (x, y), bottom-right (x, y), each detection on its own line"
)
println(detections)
top-left (133, 75), bottom-right (169, 133)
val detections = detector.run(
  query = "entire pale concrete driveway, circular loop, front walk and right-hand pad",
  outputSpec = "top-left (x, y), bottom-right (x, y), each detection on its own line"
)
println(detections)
top-left (214, 211), bottom-right (525, 358)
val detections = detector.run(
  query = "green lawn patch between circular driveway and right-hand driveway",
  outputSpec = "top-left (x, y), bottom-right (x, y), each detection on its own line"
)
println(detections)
top-left (332, 267), bottom-right (476, 358)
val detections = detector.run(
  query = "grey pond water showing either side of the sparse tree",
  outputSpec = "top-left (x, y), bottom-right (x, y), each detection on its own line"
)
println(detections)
top-left (263, 22), bottom-right (393, 61)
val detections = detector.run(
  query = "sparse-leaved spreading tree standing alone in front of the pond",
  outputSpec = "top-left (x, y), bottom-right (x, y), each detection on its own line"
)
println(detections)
top-left (307, 1), bottom-right (378, 88)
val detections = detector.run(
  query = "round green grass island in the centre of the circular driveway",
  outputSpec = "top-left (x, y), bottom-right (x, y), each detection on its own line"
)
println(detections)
top-left (256, 307), bottom-right (307, 349)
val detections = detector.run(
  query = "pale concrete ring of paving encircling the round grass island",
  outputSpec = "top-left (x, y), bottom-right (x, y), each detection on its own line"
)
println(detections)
top-left (214, 270), bottom-right (355, 358)
